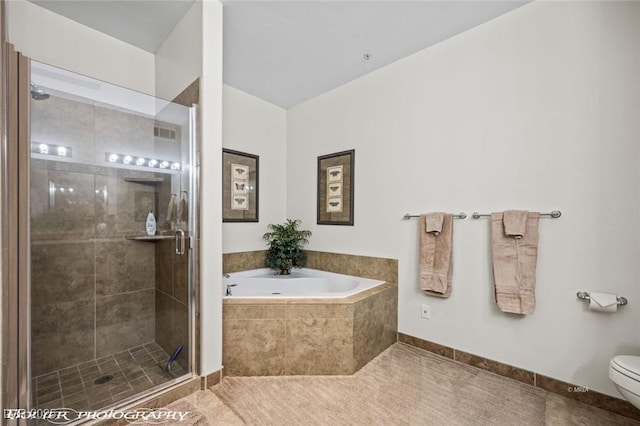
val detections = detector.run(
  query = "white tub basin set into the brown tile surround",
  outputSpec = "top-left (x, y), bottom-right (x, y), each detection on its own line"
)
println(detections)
top-left (222, 268), bottom-right (384, 299)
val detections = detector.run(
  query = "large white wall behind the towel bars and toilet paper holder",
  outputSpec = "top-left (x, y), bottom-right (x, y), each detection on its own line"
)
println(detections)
top-left (287, 2), bottom-right (640, 396)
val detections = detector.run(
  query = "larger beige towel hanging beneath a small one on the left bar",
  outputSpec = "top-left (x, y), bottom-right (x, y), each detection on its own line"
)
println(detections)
top-left (420, 214), bottom-right (453, 297)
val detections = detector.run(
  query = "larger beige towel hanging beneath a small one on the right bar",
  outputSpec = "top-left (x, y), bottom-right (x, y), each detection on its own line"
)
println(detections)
top-left (491, 212), bottom-right (540, 314)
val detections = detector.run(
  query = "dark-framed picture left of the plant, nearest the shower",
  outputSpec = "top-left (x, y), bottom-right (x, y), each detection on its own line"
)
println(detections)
top-left (222, 148), bottom-right (260, 222)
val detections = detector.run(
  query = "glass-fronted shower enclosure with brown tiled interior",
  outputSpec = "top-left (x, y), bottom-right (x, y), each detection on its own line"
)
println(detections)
top-left (29, 61), bottom-right (197, 411)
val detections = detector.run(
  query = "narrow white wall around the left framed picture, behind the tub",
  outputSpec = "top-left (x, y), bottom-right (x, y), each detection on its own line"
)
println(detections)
top-left (222, 85), bottom-right (287, 253)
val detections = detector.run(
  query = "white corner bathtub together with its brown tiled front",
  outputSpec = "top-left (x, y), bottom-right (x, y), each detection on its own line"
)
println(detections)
top-left (222, 268), bottom-right (398, 376)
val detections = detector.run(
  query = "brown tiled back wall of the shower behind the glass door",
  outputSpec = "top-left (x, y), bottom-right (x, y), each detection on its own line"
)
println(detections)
top-left (31, 92), bottom-right (179, 376)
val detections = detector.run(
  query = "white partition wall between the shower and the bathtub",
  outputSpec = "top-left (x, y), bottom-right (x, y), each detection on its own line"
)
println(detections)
top-left (156, 0), bottom-right (222, 375)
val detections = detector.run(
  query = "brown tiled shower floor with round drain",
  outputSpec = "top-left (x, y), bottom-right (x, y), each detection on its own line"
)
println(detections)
top-left (32, 342), bottom-right (186, 411)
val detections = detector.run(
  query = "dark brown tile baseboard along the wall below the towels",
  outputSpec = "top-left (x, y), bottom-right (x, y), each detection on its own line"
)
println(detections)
top-left (398, 332), bottom-right (640, 420)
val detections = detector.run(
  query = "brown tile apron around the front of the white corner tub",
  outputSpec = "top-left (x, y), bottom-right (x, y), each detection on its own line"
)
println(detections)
top-left (222, 283), bottom-right (398, 376)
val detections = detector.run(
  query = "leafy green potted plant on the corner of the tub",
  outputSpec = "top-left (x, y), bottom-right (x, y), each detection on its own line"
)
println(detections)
top-left (262, 219), bottom-right (311, 275)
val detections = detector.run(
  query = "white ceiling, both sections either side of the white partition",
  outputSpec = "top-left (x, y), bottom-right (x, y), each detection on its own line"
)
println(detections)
top-left (30, 0), bottom-right (529, 108)
